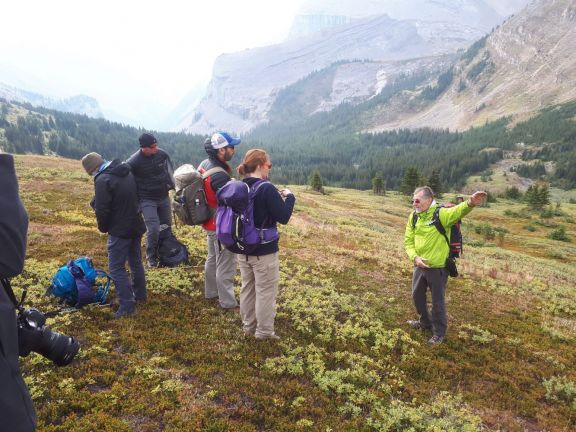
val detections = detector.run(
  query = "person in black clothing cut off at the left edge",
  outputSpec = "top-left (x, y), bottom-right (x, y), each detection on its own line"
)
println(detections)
top-left (0, 153), bottom-right (36, 432)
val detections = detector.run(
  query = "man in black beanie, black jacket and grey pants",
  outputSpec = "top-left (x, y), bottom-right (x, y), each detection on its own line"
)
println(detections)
top-left (126, 133), bottom-right (174, 267)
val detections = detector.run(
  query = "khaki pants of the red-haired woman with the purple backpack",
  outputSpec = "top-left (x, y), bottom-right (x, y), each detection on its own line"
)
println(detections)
top-left (238, 252), bottom-right (280, 337)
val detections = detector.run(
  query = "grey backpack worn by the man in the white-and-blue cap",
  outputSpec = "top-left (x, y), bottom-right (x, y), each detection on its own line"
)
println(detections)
top-left (172, 164), bottom-right (226, 225)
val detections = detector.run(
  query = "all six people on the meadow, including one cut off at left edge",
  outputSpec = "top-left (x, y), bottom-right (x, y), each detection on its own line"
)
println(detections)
top-left (0, 132), bottom-right (486, 431)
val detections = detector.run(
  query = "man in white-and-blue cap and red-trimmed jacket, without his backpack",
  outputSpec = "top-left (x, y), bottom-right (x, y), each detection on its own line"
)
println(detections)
top-left (198, 132), bottom-right (241, 310)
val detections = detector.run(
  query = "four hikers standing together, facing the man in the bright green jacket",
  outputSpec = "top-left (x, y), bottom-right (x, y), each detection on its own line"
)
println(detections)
top-left (82, 132), bottom-right (295, 339)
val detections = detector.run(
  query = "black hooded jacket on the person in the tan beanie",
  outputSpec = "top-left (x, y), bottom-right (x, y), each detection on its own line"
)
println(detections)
top-left (93, 159), bottom-right (146, 238)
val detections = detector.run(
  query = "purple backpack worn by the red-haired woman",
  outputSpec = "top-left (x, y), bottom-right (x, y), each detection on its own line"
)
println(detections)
top-left (216, 180), bottom-right (280, 254)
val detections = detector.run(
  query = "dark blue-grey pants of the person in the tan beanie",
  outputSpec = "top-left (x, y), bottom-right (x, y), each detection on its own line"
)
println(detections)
top-left (108, 235), bottom-right (146, 311)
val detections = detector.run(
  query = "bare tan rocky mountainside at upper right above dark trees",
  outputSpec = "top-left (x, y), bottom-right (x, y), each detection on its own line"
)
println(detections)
top-left (366, 0), bottom-right (576, 132)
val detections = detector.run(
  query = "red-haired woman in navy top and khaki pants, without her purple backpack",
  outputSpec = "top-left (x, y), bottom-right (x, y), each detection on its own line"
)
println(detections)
top-left (238, 149), bottom-right (296, 339)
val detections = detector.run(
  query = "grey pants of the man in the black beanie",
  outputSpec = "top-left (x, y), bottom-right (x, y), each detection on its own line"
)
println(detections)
top-left (140, 197), bottom-right (172, 267)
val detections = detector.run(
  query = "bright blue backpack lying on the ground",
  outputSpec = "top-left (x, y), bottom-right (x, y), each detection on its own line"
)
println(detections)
top-left (46, 257), bottom-right (111, 308)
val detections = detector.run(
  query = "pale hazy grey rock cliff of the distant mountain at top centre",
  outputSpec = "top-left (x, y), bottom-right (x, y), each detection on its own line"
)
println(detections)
top-left (182, 0), bottom-right (521, 133)
